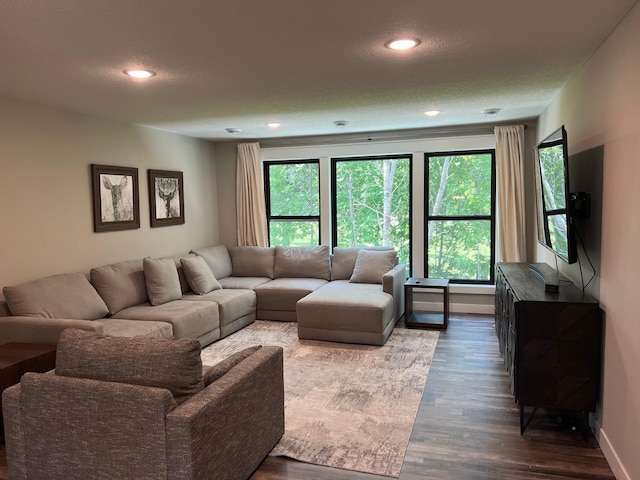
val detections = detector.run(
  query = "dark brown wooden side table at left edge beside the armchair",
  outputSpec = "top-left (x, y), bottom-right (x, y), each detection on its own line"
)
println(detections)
top-left (0, 342), bottom-right (56, 443)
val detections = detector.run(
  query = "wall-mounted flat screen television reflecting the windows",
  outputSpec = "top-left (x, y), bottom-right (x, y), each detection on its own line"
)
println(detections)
top-left (534, 125), bottom-right (578, 263)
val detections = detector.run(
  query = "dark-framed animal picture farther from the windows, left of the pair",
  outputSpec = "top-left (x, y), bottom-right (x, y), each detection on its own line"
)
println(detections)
top-left (91, 165), bottom-right (140, 232)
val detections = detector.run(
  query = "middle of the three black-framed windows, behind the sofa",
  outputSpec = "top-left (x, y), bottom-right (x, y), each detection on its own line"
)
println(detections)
top-left (332, 155), bottom-right (411, 268)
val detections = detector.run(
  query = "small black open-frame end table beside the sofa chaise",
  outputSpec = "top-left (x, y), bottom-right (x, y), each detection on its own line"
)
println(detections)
top-left (404, 278), bottom-right (449, 330)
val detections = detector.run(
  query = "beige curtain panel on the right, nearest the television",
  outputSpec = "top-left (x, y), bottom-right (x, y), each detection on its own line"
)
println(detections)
top-left (495, 125), bottom-right (527, 262)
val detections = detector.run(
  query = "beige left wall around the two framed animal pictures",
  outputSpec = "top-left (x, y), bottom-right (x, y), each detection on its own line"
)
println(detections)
top-left (0, 94), bottom-right (218, 298)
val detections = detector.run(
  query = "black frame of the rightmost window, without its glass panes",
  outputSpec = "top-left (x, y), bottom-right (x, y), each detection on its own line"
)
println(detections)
top-left (423, 148), bottom-right (496, 285)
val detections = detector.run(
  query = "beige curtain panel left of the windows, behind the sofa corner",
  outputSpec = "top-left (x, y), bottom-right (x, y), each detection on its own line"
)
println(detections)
top-left (236, 143), bottom-right (269, 247)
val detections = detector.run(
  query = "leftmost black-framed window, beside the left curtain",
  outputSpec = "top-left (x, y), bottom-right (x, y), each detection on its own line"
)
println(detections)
top-left (264, 160), bottom-right (320, 246)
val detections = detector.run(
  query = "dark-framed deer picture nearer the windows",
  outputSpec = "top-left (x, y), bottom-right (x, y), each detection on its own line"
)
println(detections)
top-left (149, 170), bottom-right (184, 227)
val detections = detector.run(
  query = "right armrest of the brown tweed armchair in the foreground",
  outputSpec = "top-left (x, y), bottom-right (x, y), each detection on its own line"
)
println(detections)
top-left (167, 347), bottom-right (284, 480)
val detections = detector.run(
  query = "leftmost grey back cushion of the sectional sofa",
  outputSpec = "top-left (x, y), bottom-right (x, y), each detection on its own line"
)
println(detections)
top-left (3, 273), bottom-right (109, 320)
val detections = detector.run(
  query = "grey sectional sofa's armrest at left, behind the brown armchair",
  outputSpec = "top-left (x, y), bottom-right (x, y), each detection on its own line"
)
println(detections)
top-left (0, 316), bottom-right (104, 345)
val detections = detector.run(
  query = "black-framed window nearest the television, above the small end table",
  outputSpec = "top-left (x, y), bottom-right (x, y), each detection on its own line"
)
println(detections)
top-left (425, 150), bottom-right (495, 283)
